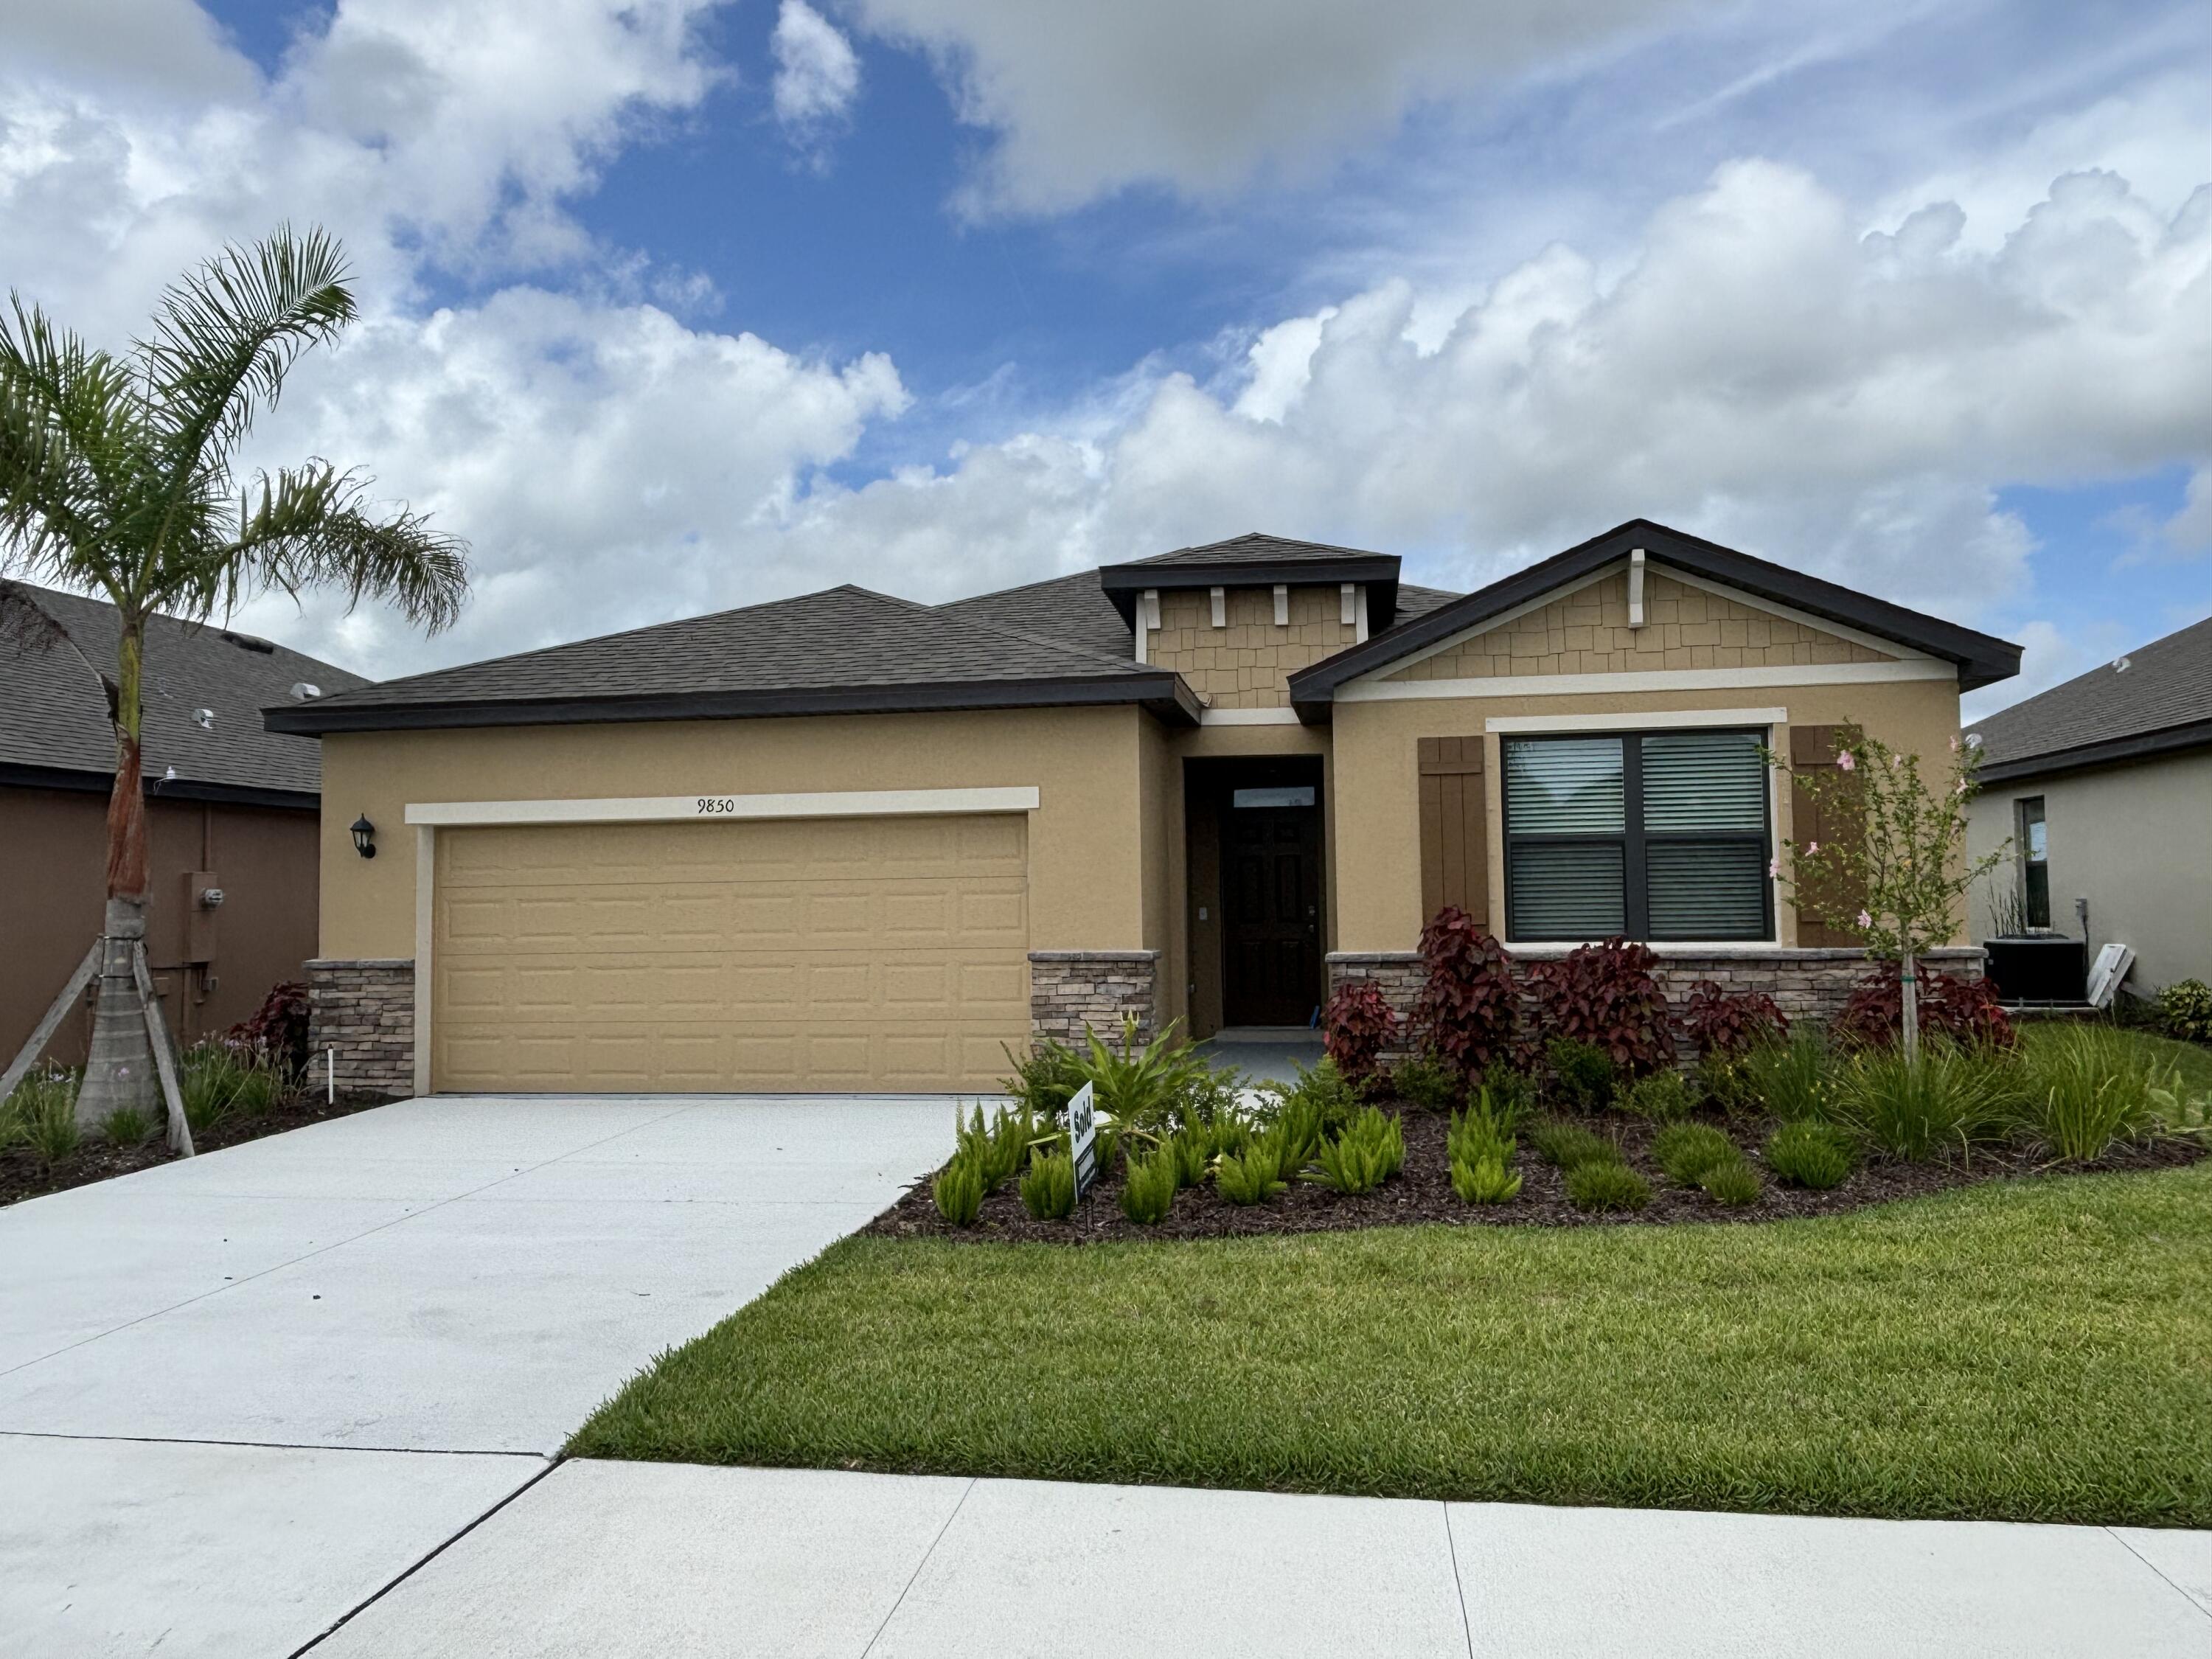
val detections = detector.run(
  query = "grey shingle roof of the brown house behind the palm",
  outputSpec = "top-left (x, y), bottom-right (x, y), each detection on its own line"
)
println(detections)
top-left (0, 582), bottom-right (367, 794)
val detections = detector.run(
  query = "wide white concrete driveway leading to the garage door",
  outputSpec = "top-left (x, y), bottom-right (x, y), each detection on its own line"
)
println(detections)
top-left (0, 1097), bottom-right (951, 1659)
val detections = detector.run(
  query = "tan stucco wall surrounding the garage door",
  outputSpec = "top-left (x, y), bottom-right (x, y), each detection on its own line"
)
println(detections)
top-left (321, 708), bottom-right (1148, 960)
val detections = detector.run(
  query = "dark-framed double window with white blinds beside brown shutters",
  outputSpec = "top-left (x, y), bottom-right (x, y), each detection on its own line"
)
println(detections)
top-left (1504, 730), bottom-right (1774, 940)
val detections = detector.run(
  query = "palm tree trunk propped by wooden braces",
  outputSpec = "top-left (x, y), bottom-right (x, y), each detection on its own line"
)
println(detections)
top-left (77, 615), bottom-right (164, 1128)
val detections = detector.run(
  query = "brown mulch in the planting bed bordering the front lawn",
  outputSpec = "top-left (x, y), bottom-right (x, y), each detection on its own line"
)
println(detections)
top-left (865, 1110), bottom-right (2205, 1243)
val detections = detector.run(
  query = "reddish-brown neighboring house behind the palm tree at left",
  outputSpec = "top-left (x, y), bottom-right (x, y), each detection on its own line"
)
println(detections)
top-left (0, 582), bottom-right (367, 1064)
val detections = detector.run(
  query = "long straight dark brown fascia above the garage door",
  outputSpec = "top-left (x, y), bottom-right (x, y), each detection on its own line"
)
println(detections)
top-left (261, 670), bottom-right (1199, 737)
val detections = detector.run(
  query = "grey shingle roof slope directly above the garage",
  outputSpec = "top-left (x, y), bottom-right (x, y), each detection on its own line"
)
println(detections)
top-left (281, 586), bottom-right (1141, 712)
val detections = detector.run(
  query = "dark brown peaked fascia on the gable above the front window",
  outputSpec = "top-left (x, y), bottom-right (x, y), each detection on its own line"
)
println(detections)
top-left (1290, 518), bottom-right (2020, 723)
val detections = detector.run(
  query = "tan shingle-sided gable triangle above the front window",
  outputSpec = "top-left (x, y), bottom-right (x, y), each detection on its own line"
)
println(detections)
top-left (1382, 571), bottom-right (1893, 679)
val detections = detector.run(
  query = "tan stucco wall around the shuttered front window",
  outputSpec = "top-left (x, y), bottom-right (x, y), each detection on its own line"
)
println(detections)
top-left (1332, 679), bottom-right (1958, 951)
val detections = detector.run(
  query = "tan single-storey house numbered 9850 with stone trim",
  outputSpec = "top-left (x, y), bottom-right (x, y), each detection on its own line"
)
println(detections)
top-left (270, 520), bottom-right (2020, 1091)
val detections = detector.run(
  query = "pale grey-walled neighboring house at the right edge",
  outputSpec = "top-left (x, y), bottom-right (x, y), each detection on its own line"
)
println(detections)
top-left (1969, 619), bottom-right (2212, 995)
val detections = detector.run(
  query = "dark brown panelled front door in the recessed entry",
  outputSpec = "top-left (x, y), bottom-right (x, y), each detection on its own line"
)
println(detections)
top-left (1221, 785), bottom-right (1321, 1026)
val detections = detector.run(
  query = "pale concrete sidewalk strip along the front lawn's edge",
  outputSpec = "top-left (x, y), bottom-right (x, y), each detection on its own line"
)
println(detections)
top-left (312, 1462), bottom-right (2212, 1659)
